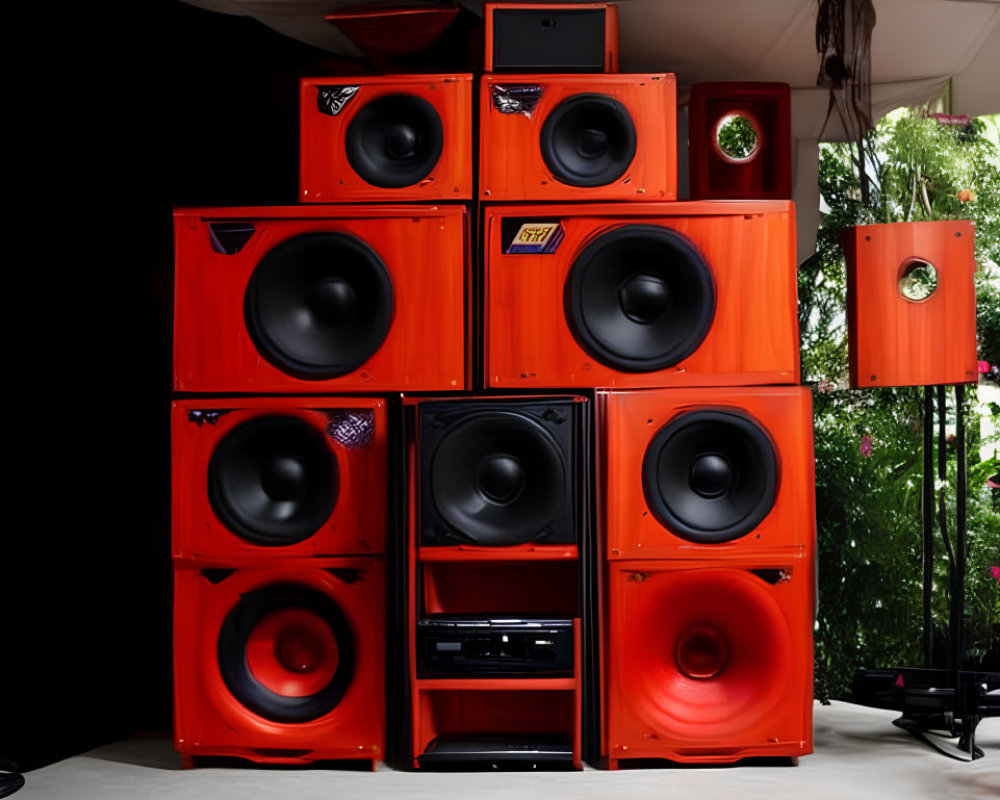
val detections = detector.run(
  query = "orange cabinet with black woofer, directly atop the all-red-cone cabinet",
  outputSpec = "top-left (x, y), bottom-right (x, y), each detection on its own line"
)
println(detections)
top-left (598, 386), bottom-right (816, 562)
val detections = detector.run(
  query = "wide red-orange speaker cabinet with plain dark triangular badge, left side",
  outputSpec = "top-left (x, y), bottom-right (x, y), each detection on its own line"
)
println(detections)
top-left (174, 206), bottom-right (469, 393)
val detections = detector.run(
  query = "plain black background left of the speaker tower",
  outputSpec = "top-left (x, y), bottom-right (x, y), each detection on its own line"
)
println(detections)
top-left (0, 0), bottom-right (327, 770)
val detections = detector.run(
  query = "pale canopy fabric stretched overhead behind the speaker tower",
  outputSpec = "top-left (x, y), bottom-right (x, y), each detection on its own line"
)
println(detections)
top-left (186, 0), bottom-right (1000, 261)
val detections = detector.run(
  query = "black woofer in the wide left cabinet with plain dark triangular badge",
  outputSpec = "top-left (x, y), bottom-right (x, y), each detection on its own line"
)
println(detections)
top-left (244, 233), bottom-right (393, 380)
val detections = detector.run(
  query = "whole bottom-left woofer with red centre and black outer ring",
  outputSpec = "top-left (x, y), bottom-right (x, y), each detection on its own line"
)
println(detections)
top-left (218, 584), bottom-right (355, 723)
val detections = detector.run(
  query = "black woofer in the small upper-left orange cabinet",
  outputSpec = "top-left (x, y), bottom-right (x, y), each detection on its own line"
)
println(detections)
top-left (344, 94), bottom-right (444, 189)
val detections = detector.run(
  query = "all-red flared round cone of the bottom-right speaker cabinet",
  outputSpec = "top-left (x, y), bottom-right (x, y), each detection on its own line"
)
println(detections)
top-left (615, 568), bottom-right (795, 741)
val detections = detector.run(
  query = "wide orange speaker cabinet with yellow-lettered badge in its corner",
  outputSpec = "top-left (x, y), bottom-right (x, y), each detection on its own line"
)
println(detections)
top-left (484, 200), bottom-right (799, 388)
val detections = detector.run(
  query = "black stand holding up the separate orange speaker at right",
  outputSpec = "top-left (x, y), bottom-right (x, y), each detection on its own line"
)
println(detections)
top-left (856, 386), bottom-right (1000, 761)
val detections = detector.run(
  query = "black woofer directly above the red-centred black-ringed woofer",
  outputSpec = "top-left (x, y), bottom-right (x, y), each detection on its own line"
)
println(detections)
top-left (208, 416), bottom-right (338, 545)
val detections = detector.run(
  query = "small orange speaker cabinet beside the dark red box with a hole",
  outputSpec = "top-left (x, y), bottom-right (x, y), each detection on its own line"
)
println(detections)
top-left (479, 74), bottom-right (677, 201)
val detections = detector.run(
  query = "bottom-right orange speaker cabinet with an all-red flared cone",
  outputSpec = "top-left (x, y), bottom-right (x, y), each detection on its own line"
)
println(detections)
top-left (605, 560), bottom-right (814, 769)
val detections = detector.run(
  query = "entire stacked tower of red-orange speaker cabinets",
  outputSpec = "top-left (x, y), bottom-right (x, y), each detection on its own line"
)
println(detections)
top-left (172, 4), bottom-right (815, 769)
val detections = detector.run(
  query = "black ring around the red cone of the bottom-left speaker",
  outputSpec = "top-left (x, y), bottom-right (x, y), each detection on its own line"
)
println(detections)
top-left (218, 584), bottom-right (355, 723)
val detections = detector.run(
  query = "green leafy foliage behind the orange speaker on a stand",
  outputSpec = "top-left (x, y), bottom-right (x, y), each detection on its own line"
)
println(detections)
top-left (799, 110), bottom-right (1000, 700)
